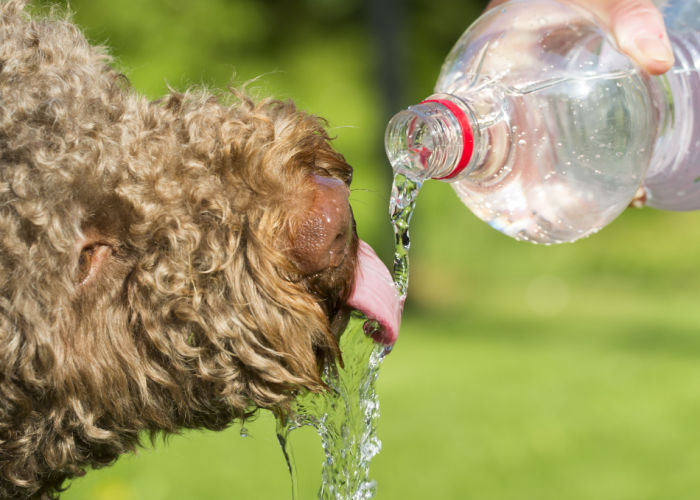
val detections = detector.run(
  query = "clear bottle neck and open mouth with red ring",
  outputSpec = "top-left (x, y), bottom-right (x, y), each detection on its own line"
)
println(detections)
top-left (385, 94), bottom-right (478, 181)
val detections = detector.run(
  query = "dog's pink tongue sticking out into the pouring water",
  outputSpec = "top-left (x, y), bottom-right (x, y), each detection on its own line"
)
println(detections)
top-left (348, 240), bottom-right (402, 345)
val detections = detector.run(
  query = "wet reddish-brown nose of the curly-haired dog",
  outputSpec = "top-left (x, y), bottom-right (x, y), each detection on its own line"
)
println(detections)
top-left (292, 175), bottom-right (354, 274)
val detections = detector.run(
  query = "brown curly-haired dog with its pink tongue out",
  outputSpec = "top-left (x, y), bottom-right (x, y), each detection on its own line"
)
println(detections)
top-left (0, 0), bottom-right (398, 499)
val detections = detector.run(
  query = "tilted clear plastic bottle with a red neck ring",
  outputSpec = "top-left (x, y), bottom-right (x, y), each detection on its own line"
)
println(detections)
top-left (385, 0), bottom-right (700, 243)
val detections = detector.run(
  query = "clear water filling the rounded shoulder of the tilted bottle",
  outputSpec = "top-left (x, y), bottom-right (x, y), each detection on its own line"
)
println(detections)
top-left (453, 72), bottom-right (652, 244)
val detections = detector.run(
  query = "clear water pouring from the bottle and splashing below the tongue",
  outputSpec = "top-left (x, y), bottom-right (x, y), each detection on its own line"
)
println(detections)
top-left (277, 170), bottom-right (421, 500)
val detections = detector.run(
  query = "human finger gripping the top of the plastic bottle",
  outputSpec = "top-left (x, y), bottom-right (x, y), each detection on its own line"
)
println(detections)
top-left (488, 0), bottom-right (674, 75)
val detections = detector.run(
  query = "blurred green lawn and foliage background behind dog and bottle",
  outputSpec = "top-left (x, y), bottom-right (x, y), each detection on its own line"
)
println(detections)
top-left (34, 0), bottom-right (700, 500)
